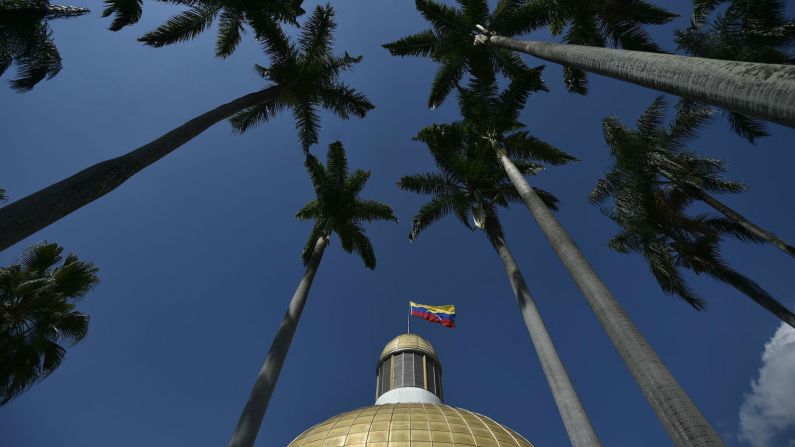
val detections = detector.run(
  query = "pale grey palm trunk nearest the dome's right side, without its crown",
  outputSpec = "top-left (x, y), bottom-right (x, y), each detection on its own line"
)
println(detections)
top-left (494, 229), bottom-right (602, 447)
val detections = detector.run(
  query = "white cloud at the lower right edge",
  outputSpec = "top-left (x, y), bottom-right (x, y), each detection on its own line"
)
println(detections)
top-left (740, 323), bottom-right (795, 447)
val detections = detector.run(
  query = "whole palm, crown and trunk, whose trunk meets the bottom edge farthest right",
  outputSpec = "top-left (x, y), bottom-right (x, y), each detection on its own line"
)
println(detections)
top-left (459, 81), bottom-right (723, 447)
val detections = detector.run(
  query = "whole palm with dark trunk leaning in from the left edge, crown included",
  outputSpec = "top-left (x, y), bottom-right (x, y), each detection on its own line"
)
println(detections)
top-left (0, 6), bottom-right (373, 254)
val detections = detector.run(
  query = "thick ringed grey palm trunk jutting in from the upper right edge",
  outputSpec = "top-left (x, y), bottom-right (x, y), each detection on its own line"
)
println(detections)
top-left (476, 34), bottom-right (795, 127)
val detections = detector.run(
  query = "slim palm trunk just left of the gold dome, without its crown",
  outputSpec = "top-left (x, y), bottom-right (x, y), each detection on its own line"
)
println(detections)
top-left (229, 236), bottom-right (328, 447)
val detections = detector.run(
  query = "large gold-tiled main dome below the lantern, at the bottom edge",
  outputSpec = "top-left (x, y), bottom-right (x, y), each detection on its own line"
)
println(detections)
top-left (288, 404), bottom-right (533, 447)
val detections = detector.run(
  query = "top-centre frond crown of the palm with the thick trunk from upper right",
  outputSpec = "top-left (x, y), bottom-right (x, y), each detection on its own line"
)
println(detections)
top-left (384, 0), bottom-right (538, 108)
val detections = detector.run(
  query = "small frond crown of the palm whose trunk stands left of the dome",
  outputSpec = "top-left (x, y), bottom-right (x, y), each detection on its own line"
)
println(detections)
top-left (295, 141), bottom-right (397, 269)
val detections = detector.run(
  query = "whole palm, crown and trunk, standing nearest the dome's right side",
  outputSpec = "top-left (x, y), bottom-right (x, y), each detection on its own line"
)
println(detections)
top-left (399, 123), bottom-right (601, 447)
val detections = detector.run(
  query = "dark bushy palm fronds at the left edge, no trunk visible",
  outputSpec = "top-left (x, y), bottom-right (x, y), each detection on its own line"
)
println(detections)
top-left (0, 242), bottom-right (99, 405)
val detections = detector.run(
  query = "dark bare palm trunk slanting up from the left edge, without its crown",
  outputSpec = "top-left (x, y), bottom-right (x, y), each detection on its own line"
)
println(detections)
top-left (0, 86), bottom-right (281, 251)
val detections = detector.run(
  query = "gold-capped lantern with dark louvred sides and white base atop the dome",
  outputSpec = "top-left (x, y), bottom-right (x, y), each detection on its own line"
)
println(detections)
top-left (375, 334), bottom-right (443, 405)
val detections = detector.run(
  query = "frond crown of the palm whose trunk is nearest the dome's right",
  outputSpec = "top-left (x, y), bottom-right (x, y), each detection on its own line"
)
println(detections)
top-left (398, 123), bottom-right (572, 245)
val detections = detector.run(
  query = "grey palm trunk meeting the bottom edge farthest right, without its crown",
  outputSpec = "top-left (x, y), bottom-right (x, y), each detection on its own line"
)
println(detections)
top-left (496, 148), bottom-right (723, 447)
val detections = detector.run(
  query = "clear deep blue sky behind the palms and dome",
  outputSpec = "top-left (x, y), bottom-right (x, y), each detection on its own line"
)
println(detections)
top-left (0, 0), bottom-right (795, 447)
